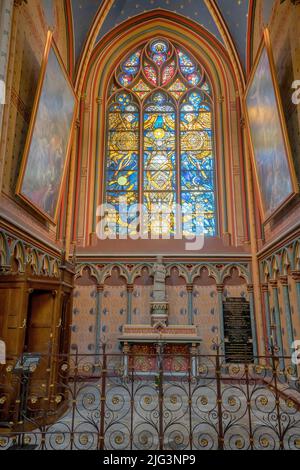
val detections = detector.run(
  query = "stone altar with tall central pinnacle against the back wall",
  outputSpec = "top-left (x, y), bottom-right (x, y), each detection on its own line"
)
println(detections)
top-left (119, 258), bottom-right (201, 376)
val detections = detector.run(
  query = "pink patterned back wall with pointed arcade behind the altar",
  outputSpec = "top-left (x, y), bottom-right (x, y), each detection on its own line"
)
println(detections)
top-left (71, 262), bottom-right (257, 355)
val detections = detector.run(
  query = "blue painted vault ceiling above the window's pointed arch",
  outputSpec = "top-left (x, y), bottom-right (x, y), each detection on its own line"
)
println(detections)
top-left (71, 0), bottom-right (249, 69)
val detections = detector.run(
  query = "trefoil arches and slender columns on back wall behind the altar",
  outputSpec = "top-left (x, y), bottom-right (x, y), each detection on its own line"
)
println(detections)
top-left (75, 263), bottom-right (259, 356)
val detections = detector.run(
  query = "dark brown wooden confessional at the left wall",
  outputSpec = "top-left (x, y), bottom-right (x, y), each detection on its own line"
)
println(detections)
top-left (0, 262), bottom-right (75, 428)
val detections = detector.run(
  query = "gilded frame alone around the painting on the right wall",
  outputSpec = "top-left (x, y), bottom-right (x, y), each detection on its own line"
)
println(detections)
top-left (243, 28), bottom-right (299, 224)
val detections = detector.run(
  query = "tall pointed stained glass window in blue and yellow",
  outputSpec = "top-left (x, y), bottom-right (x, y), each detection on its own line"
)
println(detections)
top-left (105, 38), bottom-right (217, 237)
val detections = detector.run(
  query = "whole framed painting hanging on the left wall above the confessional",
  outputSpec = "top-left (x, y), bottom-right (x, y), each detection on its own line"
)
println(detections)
top-left (16, 32), bottom-right (78, 224)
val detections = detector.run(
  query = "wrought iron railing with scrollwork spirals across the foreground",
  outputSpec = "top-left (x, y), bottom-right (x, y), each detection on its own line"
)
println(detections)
top-left (0, 350), bottom-right (300, 450)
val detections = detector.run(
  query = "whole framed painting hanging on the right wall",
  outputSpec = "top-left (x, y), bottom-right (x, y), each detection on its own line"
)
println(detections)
top-left (244, 29), bottom-right (299, 223)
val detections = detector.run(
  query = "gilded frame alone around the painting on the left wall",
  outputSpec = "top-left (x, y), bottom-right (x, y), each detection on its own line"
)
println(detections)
top-left (16, 31), bottom-right (78, 225)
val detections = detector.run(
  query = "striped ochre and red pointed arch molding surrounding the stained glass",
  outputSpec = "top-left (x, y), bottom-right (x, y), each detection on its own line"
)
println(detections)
top-left (71, 12), bottom-right (247, 247)
